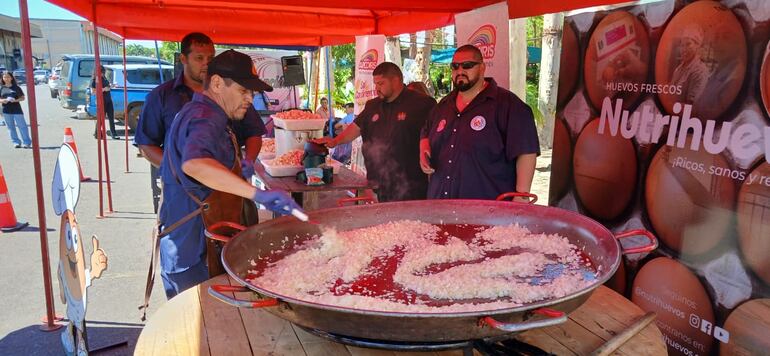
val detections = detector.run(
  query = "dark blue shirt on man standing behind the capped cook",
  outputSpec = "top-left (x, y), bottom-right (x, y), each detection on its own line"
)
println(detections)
top-left (134, 75), bottom-right (265, 147)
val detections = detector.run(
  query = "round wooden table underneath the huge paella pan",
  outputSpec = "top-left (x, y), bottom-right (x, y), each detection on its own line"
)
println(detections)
top-left (134, 275), bottom-right (666, 356)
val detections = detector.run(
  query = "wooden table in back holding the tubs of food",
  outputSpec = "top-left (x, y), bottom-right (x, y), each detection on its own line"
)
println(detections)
top-left (254, 164), bottom-right (377, 210)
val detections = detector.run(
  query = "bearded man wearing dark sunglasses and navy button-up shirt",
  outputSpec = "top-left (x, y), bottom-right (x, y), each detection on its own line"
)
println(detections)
top-left (420, 45), bottom-right (540, 199)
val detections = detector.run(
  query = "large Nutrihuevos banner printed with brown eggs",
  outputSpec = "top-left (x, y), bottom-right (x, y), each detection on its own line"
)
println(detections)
top-left (549, 0), bottom-right (770, 355)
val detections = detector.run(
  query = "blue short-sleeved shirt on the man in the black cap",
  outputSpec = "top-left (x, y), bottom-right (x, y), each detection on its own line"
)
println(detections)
top-left (160, 93), bottom-right (240, 273)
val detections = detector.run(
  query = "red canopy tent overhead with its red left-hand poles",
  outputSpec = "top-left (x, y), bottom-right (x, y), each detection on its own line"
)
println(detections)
top-left (19, 0), bottom-right (625, 330)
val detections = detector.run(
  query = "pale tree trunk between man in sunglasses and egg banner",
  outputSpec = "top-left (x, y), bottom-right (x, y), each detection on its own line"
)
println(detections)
top-left (537, 14), bottom-right (564, 149)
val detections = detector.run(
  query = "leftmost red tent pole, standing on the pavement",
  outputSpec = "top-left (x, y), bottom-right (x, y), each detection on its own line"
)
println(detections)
top-left (19, 0), bottom-right (63, 331)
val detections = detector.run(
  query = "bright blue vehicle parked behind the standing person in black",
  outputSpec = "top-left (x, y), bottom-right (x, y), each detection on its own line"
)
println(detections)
top-left (86, 64), bottom-right (174, 130)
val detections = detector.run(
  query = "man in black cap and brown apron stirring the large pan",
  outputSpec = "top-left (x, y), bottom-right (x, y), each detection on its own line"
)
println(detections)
top-left (160, 50), bottom-right (299, 298)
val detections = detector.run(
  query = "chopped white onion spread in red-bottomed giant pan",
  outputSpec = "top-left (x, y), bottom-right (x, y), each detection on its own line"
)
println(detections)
top-left (247, 220), bottom-right (596, 312)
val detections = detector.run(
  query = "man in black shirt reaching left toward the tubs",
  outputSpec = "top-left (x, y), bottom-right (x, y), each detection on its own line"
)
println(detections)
top-left (316, 62), bottom-right (436, 202)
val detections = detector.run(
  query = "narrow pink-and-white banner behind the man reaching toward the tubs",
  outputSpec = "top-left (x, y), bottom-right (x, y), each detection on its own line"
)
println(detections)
top-left (353, 35), bottom-right (384, 115)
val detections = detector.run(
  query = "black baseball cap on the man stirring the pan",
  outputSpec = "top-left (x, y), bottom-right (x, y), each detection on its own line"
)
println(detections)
top-left (208, 49), bottom-right (273, 91)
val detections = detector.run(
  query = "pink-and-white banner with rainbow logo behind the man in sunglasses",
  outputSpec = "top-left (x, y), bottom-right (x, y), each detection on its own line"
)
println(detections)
top-left (455, 2), bottom-right (510, 89)
